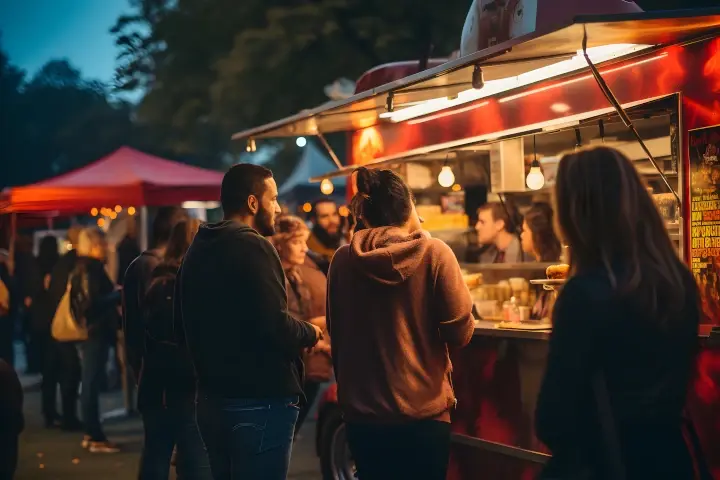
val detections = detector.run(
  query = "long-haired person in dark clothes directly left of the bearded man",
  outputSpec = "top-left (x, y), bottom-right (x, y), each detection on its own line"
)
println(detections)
top-left (138, 219), bottom-right (212, 480)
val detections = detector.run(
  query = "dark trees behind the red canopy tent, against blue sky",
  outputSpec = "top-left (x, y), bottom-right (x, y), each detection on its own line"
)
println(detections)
top-left (0, 40), bottom-right (139, 188)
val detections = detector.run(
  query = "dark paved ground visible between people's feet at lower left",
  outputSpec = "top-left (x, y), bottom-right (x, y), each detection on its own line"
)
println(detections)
top-left (15, 386), bottom-right (321, 480)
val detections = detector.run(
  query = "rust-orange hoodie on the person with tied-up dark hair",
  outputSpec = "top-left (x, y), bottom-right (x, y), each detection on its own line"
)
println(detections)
top-left (327, 227), bottom-right (474, 423)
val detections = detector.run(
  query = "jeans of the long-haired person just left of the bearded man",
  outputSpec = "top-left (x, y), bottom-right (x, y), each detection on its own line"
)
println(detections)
top-left (139, 398), bottom-right (213, 480)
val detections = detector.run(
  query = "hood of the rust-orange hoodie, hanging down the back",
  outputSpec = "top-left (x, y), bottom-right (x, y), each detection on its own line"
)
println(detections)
top-left (350, 227), bottom-right (431, 285)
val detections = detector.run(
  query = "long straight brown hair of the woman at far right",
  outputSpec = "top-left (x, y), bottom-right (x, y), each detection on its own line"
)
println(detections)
top-left (555, 147), bottom-right (689, 319)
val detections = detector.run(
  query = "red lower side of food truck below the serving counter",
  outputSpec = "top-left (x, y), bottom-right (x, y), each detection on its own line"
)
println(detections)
top-left (448, 320), bottom-right (720, 480)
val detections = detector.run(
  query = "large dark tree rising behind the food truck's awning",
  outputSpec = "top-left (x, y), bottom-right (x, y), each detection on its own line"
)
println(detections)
top-left (114, 0), bottom-right (468, 168)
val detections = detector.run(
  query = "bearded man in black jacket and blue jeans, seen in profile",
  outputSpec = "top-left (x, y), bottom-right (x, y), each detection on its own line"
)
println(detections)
top-left (180, 164), bottom-right (322, 480)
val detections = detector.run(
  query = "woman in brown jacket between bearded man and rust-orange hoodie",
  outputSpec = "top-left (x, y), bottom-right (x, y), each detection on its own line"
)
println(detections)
top-left (272, 215), bottom-right (332, 433)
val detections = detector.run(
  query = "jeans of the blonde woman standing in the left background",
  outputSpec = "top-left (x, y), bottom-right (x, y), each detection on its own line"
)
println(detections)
top-left (79, 337), bottom-right (109, 442)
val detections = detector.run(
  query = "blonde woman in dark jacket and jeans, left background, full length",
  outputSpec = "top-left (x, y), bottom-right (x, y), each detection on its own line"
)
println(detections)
top-left (75, 228), bottom-right (120, 453)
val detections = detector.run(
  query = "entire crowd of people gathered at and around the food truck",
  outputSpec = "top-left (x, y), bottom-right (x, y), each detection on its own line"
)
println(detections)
top-left (0, 147), bottom-right (701, 480)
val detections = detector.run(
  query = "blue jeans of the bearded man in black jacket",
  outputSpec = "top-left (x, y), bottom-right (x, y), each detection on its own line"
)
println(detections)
top-left (197, 395), bottom-right (300, 480)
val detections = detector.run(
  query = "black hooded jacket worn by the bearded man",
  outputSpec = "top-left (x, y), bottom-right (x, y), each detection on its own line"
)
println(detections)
top-left (175, 221), bottom-right (317, 399)
